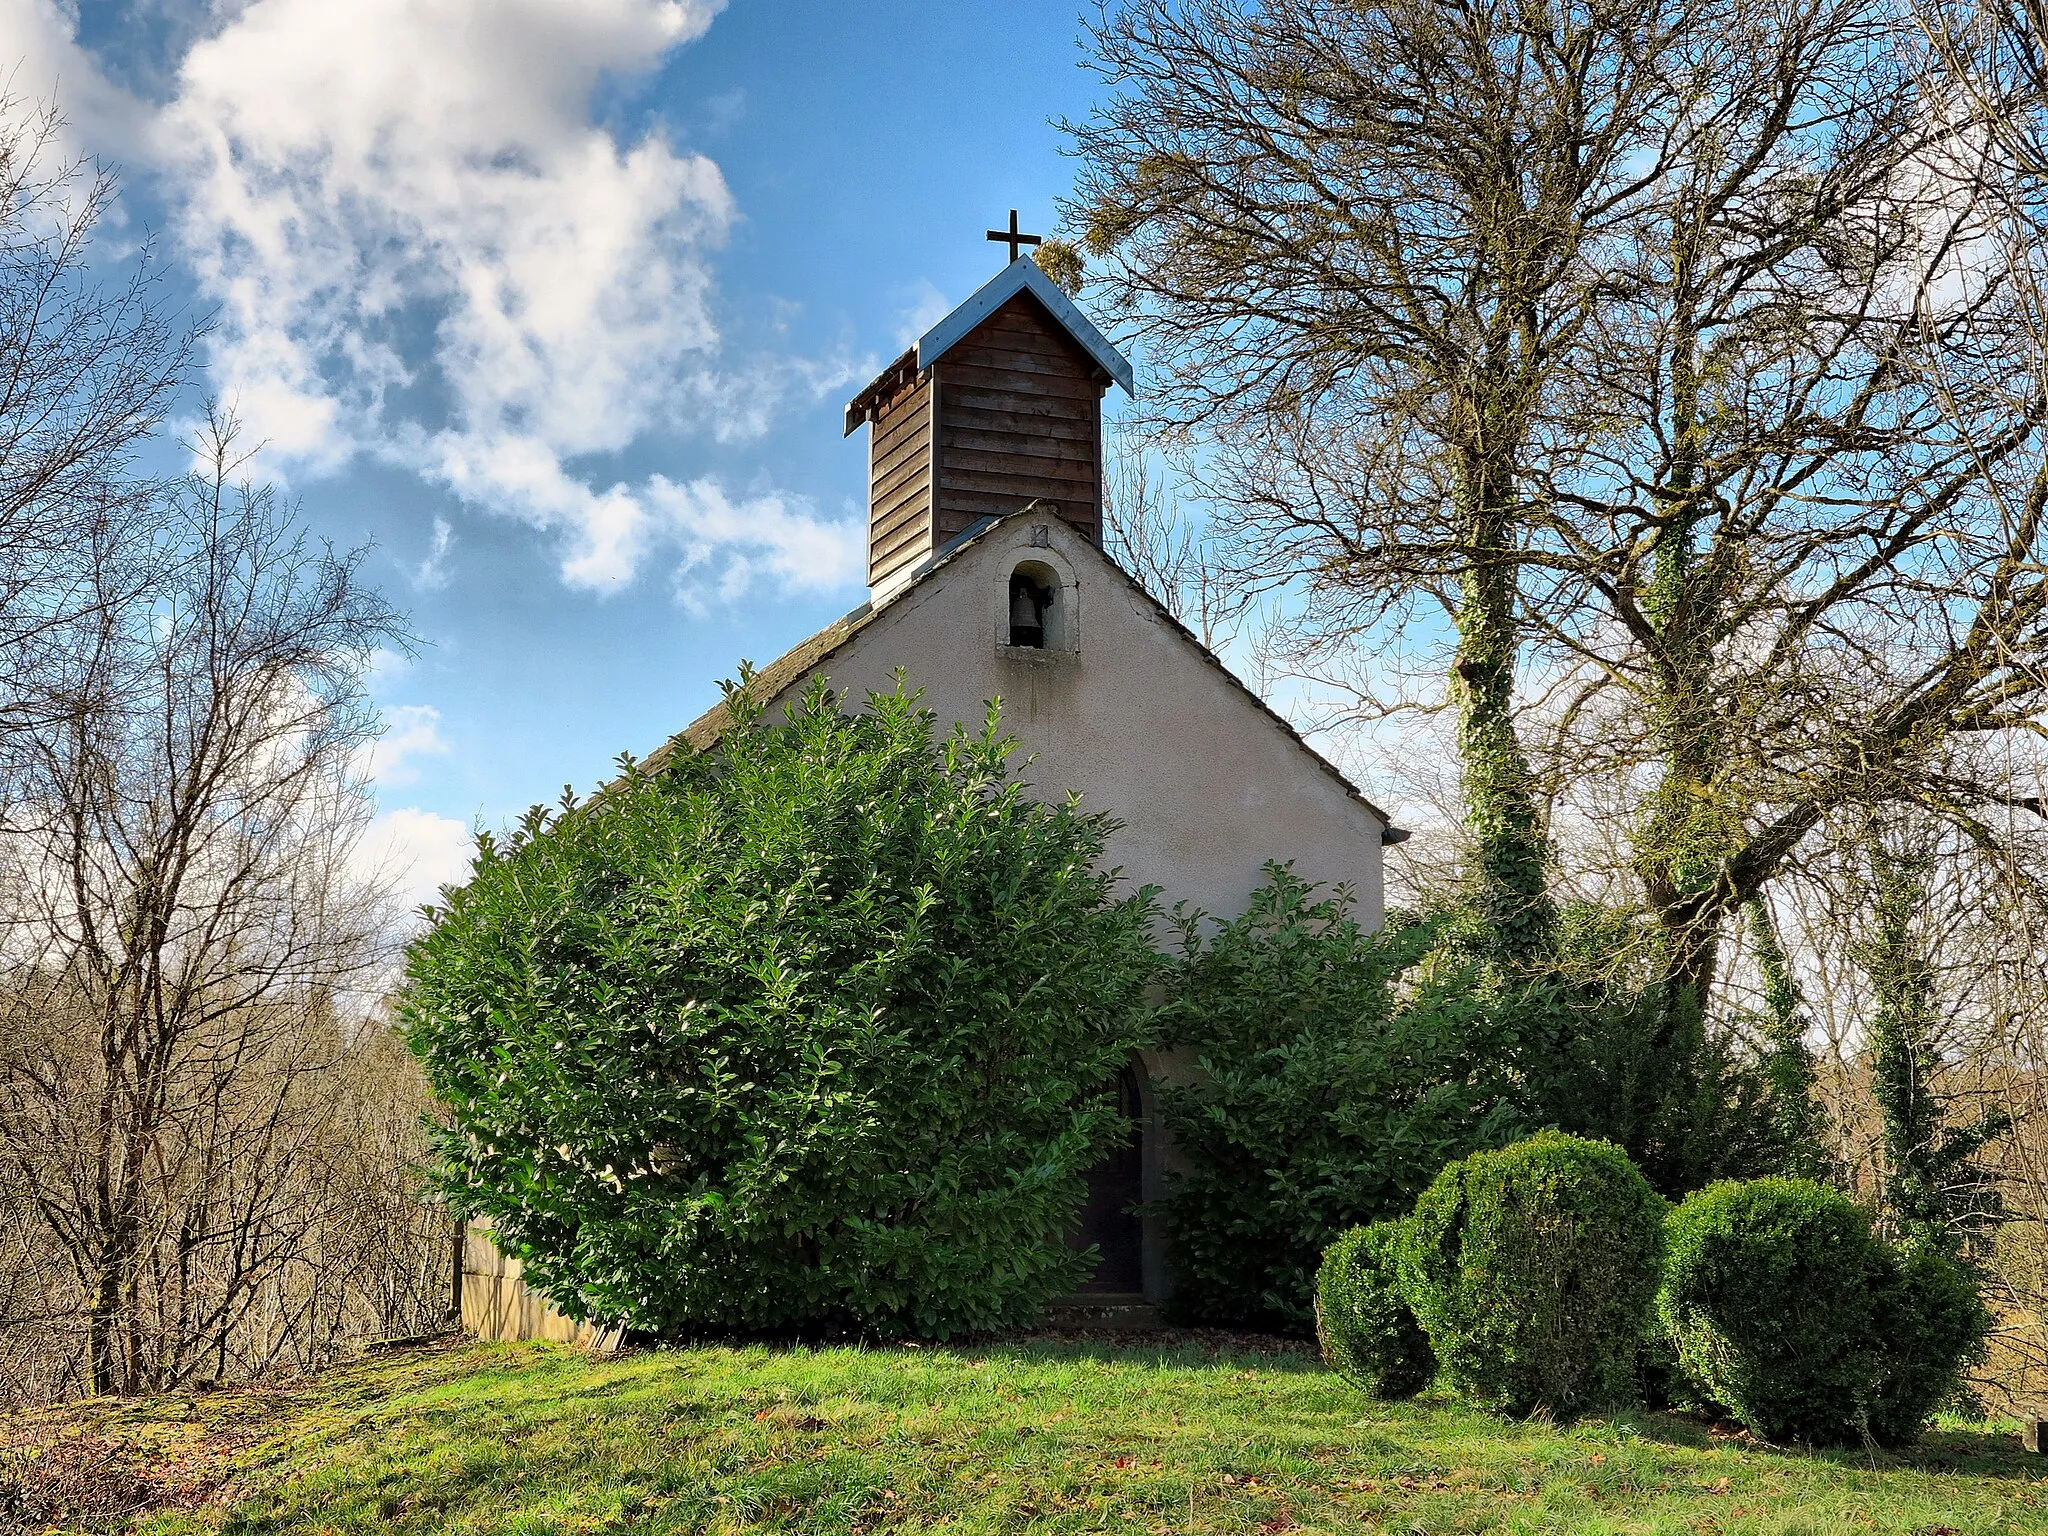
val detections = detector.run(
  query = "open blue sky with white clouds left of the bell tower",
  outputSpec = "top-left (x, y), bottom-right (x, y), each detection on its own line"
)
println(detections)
top-left (0, 0), bottom-right (1143, 909)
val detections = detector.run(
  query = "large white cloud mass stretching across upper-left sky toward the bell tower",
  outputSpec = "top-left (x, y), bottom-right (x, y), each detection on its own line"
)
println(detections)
top-left (0, 0), bottom-right (850, 592)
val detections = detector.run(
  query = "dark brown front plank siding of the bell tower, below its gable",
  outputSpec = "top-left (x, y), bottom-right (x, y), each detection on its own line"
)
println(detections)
top-left (932, 293), bottom-right (1108, 545)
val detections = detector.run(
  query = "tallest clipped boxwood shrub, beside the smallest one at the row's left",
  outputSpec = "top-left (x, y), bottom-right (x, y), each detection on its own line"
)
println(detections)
top-left (1407, 1130), bottom-right (1665, 1417)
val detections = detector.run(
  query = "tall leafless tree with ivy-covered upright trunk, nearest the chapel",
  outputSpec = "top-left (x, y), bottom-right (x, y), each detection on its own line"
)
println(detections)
top-left (1071, 0), bottom-right (1726, 961)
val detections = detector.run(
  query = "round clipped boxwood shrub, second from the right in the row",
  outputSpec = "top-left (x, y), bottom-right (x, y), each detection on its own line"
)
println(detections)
top-left (1657, 1178), bottom-right (1898, 1444)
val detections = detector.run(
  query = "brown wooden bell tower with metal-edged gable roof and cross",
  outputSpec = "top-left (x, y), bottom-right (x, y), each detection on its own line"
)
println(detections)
top-left (846, 237), bottom-right (1133, 596)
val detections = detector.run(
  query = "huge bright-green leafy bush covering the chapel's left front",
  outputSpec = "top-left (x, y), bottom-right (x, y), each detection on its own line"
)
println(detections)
top-left (401, 688), bottom-right (1157, 1335)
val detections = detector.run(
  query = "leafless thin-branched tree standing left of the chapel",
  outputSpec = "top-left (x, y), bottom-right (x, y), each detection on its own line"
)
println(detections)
top-left (0, 428), bottom-right (401, 1393)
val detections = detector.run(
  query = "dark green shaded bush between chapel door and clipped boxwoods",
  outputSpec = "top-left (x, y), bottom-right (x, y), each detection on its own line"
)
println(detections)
top-left (1159, 864), bottom-right (1520, 1331)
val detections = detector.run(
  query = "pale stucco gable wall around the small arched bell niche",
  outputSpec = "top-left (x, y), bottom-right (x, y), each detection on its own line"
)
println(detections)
top-left (770, 514), bottom-right (1384, 926)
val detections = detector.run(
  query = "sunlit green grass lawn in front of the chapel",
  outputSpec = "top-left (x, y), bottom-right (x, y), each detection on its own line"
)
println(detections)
top-left (0, 1339), bottom-right (2048, 1536)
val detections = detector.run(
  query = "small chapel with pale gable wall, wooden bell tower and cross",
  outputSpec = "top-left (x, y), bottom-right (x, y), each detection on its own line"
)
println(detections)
top-left (463, 231), bottom-right (1407, 1335)
